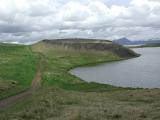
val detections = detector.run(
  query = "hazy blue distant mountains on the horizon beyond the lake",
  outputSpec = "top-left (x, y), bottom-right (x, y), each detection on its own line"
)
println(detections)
top-left (113, 38), bottom-right (160, 45)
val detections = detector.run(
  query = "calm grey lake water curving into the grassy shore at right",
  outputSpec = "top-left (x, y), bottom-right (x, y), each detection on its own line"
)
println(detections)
top-left (70, 48), bottom-right (160, 88)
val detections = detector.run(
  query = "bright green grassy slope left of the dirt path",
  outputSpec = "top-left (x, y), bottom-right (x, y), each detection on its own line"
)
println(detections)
top-left (0, 44), bottom-right (38, 99)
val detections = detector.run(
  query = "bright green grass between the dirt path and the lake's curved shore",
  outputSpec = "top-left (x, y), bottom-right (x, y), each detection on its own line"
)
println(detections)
top-left (33, 43), bottom-right (121, 91)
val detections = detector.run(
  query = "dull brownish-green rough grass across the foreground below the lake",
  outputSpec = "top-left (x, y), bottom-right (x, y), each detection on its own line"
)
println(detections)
top-left (0, 87), bottom-right (160, 120)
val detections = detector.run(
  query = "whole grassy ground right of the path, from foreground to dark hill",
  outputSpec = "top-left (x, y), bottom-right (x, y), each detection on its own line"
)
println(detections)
top-left (0, 43), bottom-right (160, 120)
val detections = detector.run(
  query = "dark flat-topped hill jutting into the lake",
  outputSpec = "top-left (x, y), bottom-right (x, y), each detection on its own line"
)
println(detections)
top-left (42, 38), bottom-right (138, 57)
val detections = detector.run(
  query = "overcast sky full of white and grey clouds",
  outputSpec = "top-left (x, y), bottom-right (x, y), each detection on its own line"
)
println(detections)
top-left (0, 0), bottom-right (160, 43)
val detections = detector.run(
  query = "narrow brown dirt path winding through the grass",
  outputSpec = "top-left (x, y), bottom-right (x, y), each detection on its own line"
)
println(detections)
top-left (0, 56), bottom-right (44, 109)
